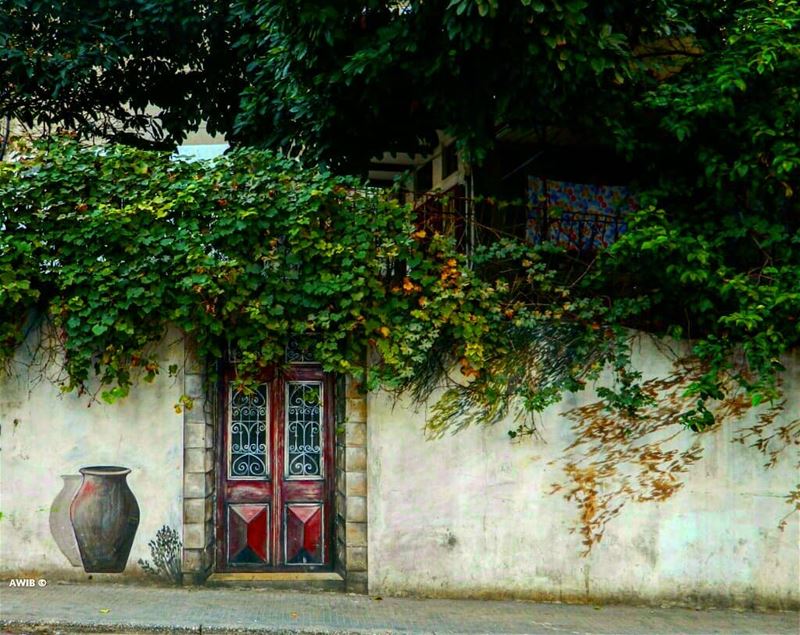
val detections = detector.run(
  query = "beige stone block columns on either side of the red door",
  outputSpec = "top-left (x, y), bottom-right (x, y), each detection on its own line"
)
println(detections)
top-left (182, 338), bottom-right (367, 593)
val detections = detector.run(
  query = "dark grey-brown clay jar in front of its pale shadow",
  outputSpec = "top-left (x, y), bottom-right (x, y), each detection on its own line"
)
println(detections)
top-left (70, 465), bottom-right (139, 573)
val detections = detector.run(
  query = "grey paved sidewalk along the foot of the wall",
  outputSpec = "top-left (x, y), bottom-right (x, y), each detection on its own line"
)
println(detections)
top-left (0, 582), bottom-right (800, 635)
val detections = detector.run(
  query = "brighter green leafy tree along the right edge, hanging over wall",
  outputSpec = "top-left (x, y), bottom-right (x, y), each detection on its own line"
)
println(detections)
top-left (595, 1), bottom-right (800, 427)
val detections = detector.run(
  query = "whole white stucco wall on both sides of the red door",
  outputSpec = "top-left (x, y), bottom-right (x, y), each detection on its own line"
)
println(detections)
top-left (0, 326), bottom-right (800, 607)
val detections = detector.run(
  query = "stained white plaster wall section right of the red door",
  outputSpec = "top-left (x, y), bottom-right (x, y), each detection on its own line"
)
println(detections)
top-left (367, 340), bottom-right (800, 607)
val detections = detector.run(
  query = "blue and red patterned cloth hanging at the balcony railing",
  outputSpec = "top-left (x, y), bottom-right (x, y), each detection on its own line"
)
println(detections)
top-left (526, 176), bottom-right (638, 252)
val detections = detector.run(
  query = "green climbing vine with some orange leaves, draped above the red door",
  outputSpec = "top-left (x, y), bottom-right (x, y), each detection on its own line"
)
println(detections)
top-left (0, 139), bottom-right (613, 414)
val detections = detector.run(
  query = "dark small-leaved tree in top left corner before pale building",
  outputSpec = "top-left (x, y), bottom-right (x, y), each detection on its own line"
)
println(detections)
top-left (0, 0), bottom-right (244, 149)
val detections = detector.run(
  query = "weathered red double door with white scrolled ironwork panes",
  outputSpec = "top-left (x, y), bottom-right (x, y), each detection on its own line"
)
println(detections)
top-left (216, 366), bottom-right (333, 572)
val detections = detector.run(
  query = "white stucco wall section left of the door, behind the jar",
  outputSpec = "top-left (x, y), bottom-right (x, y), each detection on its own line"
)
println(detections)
top-left (0, 326), bottom-right (184, 578)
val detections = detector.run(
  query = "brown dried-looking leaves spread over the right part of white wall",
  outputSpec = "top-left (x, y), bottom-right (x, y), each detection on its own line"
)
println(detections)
top-left (551, 359), bottom-right (800, 555)
